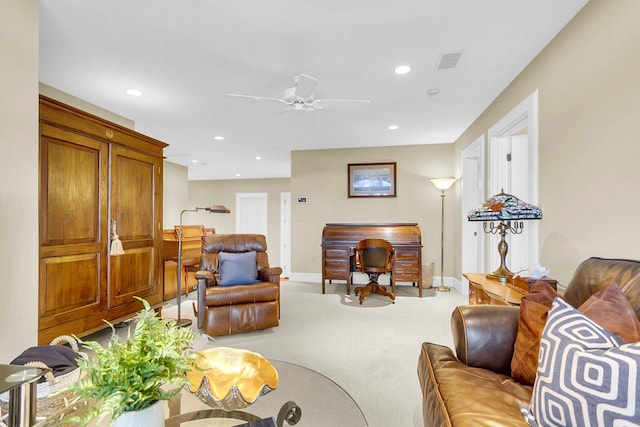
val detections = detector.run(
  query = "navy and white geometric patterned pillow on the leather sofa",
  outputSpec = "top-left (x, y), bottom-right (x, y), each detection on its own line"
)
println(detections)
top-left (522, 298), bottom-right (640, 427)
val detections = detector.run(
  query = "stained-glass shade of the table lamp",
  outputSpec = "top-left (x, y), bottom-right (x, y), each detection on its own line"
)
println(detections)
top-left (467, 191), bottom-right (542, 221)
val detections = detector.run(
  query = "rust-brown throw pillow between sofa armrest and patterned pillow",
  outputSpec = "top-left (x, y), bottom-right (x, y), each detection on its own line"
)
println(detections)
top-left (511, 280), bottom-right (557, 385)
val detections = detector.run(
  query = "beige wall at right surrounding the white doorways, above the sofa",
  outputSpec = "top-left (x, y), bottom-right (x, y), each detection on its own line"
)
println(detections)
top-left (455, 0), bottom-right (640, 285)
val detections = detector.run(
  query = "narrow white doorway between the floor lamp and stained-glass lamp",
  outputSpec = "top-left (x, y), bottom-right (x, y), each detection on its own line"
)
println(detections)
top-left (458, 135), bottom-right (485, 295)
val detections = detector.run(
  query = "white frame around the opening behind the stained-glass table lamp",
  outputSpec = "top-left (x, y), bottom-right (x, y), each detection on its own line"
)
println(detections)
top-left (486, 89), bottom-right (539, 271)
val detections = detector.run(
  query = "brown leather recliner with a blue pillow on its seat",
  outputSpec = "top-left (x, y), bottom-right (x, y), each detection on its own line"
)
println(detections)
top-left (196, 234), bottom-right (282, 336)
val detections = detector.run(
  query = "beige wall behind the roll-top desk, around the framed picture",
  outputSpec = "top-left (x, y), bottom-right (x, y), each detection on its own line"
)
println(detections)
top-left (291, 144), bottom-right (455, 276)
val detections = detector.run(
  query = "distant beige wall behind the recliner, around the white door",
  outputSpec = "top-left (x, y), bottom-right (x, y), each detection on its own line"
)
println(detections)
top-left (186, 178), bottom-right (290, 266)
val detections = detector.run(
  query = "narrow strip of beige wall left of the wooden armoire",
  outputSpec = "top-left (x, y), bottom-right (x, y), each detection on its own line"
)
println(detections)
top-left (0, 0), bottom-right (38, 363)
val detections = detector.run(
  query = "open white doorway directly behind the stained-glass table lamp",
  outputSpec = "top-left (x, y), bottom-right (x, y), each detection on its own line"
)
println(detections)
top-left (485, 90), bottom-right (538, 273)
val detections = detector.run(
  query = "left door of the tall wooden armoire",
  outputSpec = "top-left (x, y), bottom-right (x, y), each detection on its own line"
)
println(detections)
top-left (38, 124), bottom-right (109, 333)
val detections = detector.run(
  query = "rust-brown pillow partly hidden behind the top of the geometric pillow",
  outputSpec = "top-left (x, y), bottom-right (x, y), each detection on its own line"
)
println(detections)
top-left (578, 285), bottom-right (640, 343)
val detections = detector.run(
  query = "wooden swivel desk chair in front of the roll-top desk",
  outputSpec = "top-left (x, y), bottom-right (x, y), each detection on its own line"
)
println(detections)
top-left (353, 239), bottom-right (396, 304)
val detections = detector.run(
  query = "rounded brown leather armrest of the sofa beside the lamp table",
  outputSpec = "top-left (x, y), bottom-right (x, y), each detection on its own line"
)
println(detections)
top-left (451, 305), bottom-right (520, 375)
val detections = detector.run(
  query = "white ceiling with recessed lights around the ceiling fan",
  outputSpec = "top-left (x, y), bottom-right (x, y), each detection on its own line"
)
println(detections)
top-left (40, 0), bottom-right (587, 180)
